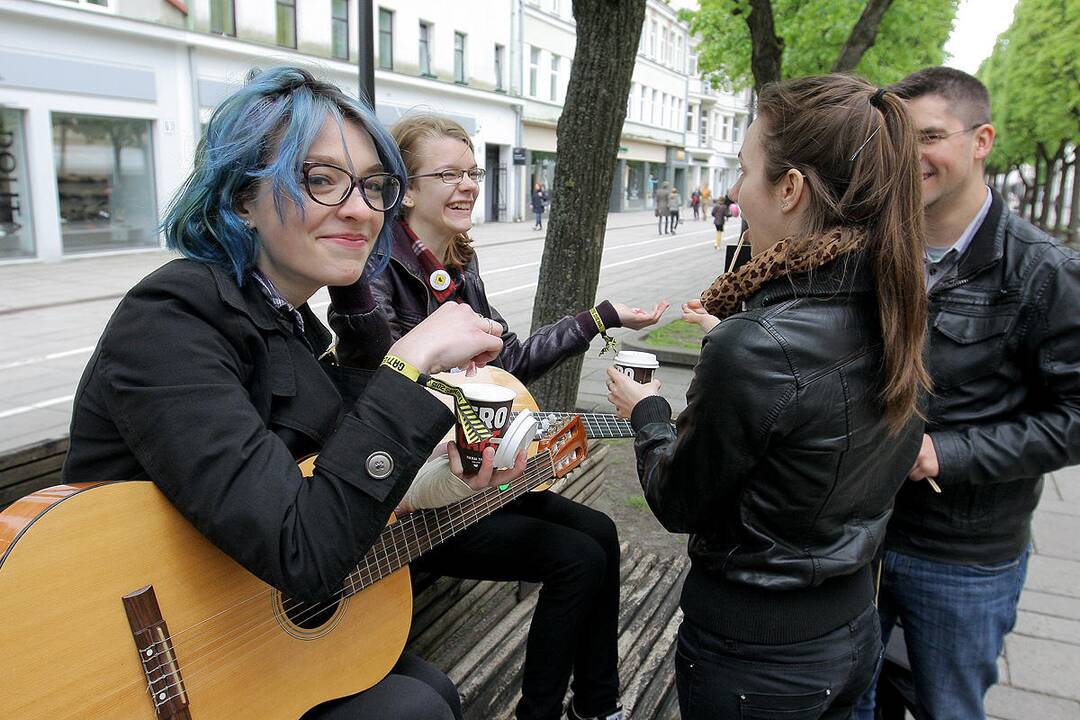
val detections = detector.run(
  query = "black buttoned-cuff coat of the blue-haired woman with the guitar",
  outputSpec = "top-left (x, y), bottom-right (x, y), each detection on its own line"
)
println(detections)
top-left (64, 260), bottom-right (454, 599)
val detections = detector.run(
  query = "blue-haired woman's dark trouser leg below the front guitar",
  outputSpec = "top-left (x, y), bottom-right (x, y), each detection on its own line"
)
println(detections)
top-left (301, 654), bottom-right (461, 720)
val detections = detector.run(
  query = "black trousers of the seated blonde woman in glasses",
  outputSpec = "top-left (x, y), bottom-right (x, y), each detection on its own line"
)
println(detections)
top-left (416, 492), bottom-right (619, 720)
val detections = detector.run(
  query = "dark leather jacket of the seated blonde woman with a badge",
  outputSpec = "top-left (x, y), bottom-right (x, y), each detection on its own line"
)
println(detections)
top-left (328, 222), bottom-right (596, 383)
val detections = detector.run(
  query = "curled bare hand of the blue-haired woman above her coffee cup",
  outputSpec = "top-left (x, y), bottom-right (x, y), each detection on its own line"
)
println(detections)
top-left (390, 302), bottom-right (502, 375)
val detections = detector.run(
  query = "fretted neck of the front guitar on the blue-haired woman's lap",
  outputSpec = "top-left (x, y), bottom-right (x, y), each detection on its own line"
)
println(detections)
top-left (342, 450), bottom-right (555, 597)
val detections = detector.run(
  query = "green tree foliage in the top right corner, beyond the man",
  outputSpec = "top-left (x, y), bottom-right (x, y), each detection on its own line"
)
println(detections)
top-left (978, 0), bottom-right (1080, 172)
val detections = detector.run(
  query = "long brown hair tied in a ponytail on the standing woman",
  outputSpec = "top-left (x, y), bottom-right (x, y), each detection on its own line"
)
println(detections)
top-left (758, 74), bottom-right (930, 432)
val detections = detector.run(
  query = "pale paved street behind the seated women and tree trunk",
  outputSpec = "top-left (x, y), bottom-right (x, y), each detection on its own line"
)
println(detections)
top-left (0, 212), bottom-right (738, 451)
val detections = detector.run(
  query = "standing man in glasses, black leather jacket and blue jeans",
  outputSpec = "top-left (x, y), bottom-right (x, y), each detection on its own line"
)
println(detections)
top-left (858, 68), bottom-right (1080, 720)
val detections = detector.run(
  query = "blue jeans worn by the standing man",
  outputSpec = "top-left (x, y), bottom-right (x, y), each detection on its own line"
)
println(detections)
top-left (855, 549), bottom-right (1030, 720)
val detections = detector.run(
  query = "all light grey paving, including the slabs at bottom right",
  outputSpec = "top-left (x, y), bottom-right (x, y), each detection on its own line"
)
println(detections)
top-left (0, 213), bottom-right (1080, 720)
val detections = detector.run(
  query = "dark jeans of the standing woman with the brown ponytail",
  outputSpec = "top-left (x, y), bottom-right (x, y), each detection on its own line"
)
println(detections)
top-left (675, 598), bottom-right (881, 720)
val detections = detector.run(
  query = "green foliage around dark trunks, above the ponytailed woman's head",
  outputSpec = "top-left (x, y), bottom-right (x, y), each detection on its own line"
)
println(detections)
top-left (681, 0), bottom-right (959, 89)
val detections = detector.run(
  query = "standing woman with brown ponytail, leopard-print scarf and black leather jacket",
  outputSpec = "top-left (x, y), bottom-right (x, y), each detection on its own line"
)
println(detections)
top-left (608, 74), bottom-right (928, 720)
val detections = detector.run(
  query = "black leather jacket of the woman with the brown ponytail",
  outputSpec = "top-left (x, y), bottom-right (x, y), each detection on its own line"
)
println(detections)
top-left (631, 255), bottom-right (922, 643)
